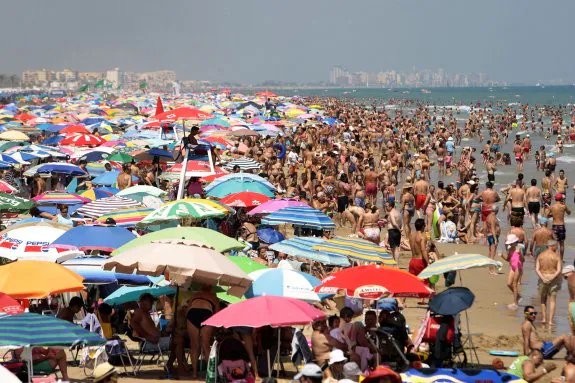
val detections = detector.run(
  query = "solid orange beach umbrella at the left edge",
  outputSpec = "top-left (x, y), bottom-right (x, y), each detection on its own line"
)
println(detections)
top-left (0, 261), bottom-right (84, 299)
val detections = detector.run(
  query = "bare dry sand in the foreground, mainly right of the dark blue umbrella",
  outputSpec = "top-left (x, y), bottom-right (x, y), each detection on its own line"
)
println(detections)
top-left (58, 245), bottom-right (567, 383)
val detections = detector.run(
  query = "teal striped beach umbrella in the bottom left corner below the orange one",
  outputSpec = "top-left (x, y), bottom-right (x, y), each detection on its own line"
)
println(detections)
top-left (0, 313), bottom-right (106, 347)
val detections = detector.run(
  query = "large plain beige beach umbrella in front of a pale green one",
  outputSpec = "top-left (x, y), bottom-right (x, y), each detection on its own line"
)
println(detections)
top-left (104, 240), bottom-right (252, 297)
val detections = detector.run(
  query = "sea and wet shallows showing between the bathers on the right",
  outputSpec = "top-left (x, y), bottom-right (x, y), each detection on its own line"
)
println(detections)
top-left (277, 86), bottom-right (575, 338)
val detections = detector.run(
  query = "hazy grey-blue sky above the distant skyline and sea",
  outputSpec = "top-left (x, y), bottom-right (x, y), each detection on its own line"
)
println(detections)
top-left (4, 0), bottom-right (575, 82)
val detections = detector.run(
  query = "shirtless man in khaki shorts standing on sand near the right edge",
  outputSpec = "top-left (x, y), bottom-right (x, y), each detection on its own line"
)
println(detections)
top-left (535, 239), bottom-right (563, 326)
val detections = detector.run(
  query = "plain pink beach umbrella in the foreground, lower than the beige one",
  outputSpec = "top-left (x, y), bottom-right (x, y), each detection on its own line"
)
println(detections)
top-left (203, 296), bottom-right (326, 328)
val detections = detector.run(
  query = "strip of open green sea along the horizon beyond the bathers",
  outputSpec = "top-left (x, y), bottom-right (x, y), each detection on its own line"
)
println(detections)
top-left (276, 85), bottom-right (575, 105)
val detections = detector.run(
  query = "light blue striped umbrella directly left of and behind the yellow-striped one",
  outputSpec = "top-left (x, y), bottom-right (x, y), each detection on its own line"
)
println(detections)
top-left (270, 237), bottom-right (350, 267)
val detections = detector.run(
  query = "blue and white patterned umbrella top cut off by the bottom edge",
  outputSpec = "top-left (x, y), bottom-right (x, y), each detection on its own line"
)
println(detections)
top-left (401, 368), bottom-right (526, 383)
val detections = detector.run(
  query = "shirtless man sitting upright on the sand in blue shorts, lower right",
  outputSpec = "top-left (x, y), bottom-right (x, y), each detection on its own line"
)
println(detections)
top-left (521, 306), bottom-right (573, 359)
